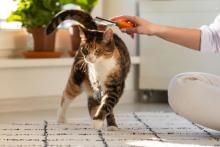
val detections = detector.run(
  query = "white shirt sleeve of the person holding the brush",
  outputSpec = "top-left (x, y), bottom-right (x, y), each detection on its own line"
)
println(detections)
top-left (200, 14), bottom-right (220, 53)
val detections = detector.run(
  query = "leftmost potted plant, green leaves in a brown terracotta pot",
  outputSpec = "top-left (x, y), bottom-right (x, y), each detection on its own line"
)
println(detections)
top-left (7, 0), bottom-right (62, 57)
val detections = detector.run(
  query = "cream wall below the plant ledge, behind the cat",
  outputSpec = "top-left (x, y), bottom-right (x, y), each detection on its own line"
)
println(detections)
top-left (0, 58), bottom-right (137, 112)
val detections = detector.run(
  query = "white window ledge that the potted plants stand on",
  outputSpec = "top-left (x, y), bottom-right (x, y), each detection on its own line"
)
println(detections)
top-left (0, 56), bottom-right (140, 68)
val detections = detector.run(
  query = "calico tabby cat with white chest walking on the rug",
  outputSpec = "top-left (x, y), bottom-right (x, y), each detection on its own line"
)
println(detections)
top-left (46, 10), bottom-right (130, 130)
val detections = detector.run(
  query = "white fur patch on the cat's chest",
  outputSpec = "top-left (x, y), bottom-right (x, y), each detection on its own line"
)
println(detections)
top-left (89, 58), bottom-right (116, 87)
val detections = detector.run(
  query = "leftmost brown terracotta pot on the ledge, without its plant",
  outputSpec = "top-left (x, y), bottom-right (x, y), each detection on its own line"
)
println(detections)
top-left (28, 28), bottom-right (56, 52)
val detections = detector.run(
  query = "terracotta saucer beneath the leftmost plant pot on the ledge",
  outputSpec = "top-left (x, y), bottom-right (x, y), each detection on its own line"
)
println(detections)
top-left (23, 51), bottom-right (63, 58)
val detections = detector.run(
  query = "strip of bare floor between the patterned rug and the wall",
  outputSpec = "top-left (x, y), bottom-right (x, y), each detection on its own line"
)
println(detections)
top-left (0, 103), bottom-right (172, 123)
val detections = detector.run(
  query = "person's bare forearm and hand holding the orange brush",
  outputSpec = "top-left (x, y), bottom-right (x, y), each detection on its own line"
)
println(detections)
top-left (112, 16), bottom-right (201, 50)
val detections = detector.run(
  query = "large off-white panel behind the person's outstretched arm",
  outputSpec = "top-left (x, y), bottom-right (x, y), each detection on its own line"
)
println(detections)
top-left (139, 0), bottom-right (220, 90)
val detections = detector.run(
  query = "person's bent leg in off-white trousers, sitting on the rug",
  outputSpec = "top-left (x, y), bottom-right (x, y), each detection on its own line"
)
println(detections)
top-left (168, 73), bottom-right (220, 130)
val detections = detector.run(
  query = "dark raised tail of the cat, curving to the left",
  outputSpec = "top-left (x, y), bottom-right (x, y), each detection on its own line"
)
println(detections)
top-left (46, 10), bottom-right (97, 35)
